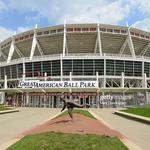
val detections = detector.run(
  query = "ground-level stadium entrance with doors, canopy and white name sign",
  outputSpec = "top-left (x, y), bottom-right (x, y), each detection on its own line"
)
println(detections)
top-left (1, 80), bottom-right (150, 108)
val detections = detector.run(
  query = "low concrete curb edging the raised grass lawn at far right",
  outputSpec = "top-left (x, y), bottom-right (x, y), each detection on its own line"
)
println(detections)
top-left (114, 110), bottom-right (150, 125)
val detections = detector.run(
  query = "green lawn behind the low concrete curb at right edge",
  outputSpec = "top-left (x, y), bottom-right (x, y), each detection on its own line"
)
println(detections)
top-left (121, 105), bottom-right (150, 118)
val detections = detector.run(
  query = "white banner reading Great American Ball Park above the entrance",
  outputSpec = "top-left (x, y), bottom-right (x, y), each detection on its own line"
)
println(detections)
top-left (18, 80), bottom-right (98, 88)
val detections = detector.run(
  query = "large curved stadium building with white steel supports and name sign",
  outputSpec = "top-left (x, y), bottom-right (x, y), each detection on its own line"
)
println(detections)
top-left (0, 24), bottom-right (150, 108)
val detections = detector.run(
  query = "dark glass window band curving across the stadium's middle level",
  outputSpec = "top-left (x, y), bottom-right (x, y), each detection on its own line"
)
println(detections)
top-left (0, 59), bottom-right (150, 80)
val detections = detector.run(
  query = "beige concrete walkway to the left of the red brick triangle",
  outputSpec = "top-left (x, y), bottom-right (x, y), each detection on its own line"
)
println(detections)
top-left (0, 108), bottom-right (60, 149)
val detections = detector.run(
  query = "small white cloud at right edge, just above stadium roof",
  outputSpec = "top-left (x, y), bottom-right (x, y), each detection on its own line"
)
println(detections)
top-left (133, 18), bottom-right (150, 32)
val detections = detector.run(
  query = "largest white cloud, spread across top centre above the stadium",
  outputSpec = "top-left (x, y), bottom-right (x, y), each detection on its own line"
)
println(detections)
top-left (11, 0), bottom-right (130, 24)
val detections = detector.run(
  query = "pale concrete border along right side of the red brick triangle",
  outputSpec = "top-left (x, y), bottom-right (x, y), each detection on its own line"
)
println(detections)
top-left (89, 110), bottom-right (142, 150)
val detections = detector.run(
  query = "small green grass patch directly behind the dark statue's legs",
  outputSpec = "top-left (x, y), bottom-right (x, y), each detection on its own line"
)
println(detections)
top-left (57, 109), bottom-right (96, 120)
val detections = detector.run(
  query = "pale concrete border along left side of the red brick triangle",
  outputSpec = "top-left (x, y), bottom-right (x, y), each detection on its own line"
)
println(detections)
top-left (0, 109), bottom-right (62, 150)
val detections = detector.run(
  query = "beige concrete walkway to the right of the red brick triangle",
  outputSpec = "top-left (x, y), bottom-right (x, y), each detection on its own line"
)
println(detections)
top-left (91, 108), bottom-right (150, 150)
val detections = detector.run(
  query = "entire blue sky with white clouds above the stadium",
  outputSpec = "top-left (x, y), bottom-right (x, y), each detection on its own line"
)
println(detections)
top-left (0, 0), bottom-right (150, 41)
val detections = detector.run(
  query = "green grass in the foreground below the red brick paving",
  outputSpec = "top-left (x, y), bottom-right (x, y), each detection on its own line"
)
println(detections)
top-left (8, 132), bottom-right (128, 150)
